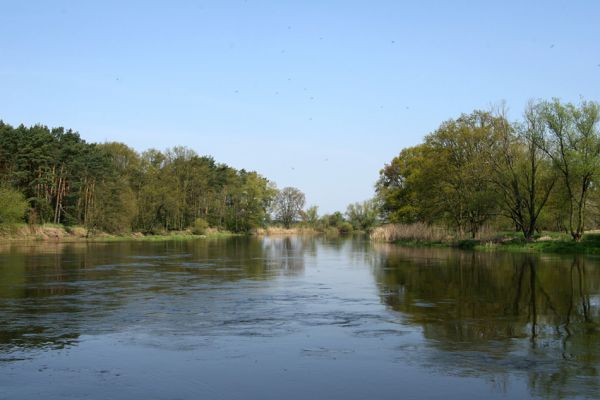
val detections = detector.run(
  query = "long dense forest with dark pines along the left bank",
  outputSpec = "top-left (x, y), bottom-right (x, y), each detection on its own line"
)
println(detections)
top-left (0, 121), bottom-right (277, 233)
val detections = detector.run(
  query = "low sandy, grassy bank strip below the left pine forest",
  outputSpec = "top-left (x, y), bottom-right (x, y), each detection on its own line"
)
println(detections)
top-left (0, 224), bottom-right (239, 242)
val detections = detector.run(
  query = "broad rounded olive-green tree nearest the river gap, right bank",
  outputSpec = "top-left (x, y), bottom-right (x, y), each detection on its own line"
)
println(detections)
top-left (376, 111), bottom-right (498, 237)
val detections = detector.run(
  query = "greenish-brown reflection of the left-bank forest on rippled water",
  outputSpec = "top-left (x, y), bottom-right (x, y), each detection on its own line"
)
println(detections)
top-left (0, 237), bottom-right (308, 353)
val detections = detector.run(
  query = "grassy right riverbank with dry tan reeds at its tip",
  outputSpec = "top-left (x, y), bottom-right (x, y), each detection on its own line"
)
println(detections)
top-left (371, 224), bottom-right (600, 254)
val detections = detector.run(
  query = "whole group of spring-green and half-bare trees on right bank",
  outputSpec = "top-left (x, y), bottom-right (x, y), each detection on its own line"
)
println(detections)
top-left (376, 99), bottom-right (600, 241)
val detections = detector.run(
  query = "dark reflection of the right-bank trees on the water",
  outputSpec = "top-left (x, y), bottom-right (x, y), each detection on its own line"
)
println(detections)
top-left (373, 245), bottom-right (600, 398)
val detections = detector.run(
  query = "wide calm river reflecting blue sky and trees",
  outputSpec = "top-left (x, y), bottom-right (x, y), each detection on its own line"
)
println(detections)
top-left (0, 237), bottom-right (600, 400)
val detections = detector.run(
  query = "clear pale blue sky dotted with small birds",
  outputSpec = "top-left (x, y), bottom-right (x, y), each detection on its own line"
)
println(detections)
top-left (0, 0), bottom-right (600, 213)
